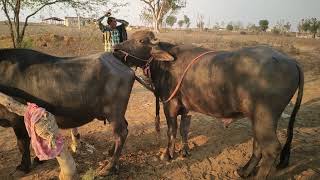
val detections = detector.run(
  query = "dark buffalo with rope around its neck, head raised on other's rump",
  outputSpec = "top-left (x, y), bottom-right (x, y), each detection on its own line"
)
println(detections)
top-left (115, 31), bottom-right (304, 179)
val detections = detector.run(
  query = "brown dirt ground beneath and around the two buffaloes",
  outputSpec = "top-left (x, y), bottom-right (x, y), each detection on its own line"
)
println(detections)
top-left (0, 24), bottom-right (320, 180)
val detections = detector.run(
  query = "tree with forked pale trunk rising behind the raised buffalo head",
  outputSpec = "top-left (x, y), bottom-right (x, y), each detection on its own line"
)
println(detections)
top-left (140, 0), bottom-right (184, 32)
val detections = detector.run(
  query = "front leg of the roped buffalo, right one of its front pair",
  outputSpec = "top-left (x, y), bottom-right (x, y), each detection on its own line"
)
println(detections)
top-left (180, 114), bottom-right (191, 157)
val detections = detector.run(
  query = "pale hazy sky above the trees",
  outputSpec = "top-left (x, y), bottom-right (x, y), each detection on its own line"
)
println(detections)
top-left (0, 0), bottom-right (320, 30)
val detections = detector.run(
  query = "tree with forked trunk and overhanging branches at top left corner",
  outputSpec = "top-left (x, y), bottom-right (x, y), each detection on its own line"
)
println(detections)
top-left (0, 0), bottom-right (110, 48)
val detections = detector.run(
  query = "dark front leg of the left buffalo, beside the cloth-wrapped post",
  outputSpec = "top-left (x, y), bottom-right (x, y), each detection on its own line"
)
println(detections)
top-left (12, 119), bottom-right (31, 173)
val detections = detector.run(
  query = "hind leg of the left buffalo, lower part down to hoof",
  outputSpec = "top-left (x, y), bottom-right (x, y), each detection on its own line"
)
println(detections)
top-left (99, 116), bottom-right (128, 176)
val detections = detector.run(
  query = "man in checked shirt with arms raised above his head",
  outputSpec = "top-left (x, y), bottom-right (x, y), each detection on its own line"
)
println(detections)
top-left (97, 12), bottom-right (129, 52)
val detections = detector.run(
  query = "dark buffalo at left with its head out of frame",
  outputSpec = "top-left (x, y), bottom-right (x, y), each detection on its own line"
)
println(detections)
top-left (0, 49), bottom-right (135, 174)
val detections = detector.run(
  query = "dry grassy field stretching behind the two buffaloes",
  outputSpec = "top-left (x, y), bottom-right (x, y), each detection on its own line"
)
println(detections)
top-left (0, 24), bottom-right (320, 56)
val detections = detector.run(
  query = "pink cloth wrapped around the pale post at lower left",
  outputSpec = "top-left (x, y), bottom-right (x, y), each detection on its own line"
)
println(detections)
top-left (24, 103), bottom-right (63, 160)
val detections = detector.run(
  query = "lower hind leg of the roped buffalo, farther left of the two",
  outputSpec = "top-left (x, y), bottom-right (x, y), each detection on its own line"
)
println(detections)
top-left (237, 138), bottom-right (261, 178)
